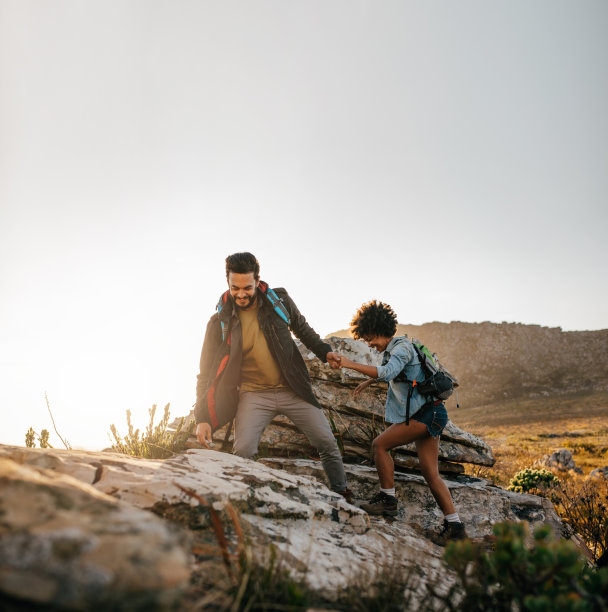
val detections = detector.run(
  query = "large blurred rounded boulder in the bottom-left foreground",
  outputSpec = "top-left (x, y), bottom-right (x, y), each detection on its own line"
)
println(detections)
top-left (0, 454), bottom-right (190, 610)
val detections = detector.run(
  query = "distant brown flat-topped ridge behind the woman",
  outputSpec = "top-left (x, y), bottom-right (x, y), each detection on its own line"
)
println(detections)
top-left (327, 321), bottom-right (608, 407)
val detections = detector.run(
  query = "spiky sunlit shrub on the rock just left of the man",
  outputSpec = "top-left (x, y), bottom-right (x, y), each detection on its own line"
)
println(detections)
top-left (110, 404), bottom-right (194, 459)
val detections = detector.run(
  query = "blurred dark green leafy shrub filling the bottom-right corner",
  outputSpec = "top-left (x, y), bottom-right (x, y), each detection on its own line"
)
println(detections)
top-left (444, 523), bottom-right (608, 612)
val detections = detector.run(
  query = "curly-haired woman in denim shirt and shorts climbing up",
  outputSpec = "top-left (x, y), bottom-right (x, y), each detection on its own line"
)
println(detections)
top-left (340, 300), bottom-right (467, 544)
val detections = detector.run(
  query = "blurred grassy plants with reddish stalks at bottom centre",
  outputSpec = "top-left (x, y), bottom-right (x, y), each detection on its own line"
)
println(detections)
top-left (178, 485), bottom-right (435, 612)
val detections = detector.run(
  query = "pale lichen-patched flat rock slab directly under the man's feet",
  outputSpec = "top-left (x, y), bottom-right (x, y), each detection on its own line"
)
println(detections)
top-left (0, 446), bottom-right (366, 526)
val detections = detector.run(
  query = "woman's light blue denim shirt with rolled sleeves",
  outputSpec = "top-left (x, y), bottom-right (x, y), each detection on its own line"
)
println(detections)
top-left (377, 336), bottom-right (427, 423)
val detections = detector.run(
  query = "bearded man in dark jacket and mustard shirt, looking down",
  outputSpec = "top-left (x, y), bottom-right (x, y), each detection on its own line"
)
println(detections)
top-left (195, 253), bottom-right (352, 501)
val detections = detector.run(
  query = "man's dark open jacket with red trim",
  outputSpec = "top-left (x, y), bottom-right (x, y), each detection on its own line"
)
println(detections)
top-left (194, 288), bottom-right (331, 430)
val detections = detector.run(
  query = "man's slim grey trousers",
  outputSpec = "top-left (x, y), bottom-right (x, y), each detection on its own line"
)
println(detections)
top-left (232, 388), bottom-right (346, 491)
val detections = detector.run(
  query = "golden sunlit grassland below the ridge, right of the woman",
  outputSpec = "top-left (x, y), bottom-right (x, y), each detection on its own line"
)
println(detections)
top-left (451, 393), bottom-right (608, 560)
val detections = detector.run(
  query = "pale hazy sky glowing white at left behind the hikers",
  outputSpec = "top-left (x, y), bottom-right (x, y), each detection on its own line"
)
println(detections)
top-left (0, 0), bottom-right (608, 449)
